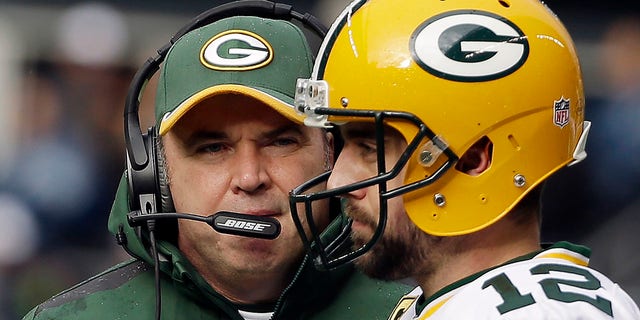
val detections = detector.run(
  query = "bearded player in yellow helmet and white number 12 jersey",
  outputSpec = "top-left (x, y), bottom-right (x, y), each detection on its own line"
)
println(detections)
top-left (291, 0), bottom-right (640, 319)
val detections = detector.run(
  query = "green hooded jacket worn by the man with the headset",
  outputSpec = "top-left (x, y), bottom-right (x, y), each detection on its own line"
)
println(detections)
top-left (23, 177), bottom-right (410, 320)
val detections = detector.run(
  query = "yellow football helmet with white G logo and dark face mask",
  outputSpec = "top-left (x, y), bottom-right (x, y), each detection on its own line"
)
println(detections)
top-left (291, 0), bottom-right (590, 268)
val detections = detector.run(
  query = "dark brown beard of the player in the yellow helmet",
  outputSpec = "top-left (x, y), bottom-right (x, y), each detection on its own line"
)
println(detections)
top-left (345, 205), bottom-right (445, 281)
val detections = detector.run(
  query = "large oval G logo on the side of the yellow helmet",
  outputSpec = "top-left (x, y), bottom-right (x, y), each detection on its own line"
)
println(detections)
top-left (410, 10), bottom-right (529, 82)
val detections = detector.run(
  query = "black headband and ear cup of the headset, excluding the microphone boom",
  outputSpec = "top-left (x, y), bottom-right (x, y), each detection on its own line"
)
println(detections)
top-left (124, 0), bottom-right (327, 222)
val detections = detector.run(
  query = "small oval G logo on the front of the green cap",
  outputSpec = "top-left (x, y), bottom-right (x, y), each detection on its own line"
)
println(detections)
top-left (200, 30), bottom-right (273, 71)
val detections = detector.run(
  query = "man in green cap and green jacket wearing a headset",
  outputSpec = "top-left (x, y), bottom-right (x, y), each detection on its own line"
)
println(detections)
top-left (25, 3), bottom-right (408, 319)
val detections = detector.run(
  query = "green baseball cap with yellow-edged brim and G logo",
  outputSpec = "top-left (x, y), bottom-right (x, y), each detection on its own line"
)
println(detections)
top-left (155, 16), bottom-right (313, 135)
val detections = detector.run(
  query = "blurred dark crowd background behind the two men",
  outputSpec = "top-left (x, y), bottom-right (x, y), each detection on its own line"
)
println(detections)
top-left (0, 0), bottom-right (640, 320)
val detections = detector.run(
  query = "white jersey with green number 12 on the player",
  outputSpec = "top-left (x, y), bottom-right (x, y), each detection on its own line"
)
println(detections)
top-left (389, 242), bottom-right (640, 320)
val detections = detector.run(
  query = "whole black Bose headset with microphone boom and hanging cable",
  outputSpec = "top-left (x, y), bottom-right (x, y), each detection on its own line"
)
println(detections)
top-left (121, 0), bottom-right (327, 319)
